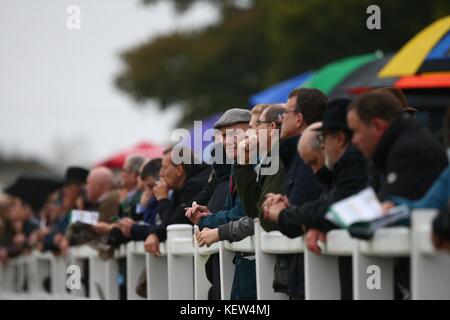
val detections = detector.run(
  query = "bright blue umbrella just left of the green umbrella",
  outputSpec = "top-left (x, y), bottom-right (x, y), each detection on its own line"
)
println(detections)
top-left (249, 72), bottom-right (313, 107)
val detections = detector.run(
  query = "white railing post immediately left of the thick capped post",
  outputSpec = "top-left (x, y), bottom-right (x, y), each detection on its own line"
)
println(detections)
top-left (145, 242), bottom-right (169, 300)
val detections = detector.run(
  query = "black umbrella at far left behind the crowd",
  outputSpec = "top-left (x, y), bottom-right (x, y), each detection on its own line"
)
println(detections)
top-left (4, 175), bottom-right (63, 211)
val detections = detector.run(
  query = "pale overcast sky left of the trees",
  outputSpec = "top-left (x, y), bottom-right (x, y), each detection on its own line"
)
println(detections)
top-left (0, 0), bottom-right (217, 170)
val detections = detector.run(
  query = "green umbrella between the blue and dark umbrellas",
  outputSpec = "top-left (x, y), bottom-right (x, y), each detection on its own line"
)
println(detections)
top-left (302, 53), bottom-right (382, 95)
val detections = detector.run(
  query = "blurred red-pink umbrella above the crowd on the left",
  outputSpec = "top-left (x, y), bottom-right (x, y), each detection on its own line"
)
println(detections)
top-left (96, 142), bottom-right (165, 169)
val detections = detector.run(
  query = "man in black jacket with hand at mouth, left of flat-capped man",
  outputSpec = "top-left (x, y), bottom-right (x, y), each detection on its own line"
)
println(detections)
top-left (144, 147), bottom-right (211, 255)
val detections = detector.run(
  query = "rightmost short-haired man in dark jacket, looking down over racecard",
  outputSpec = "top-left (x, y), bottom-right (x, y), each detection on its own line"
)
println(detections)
top-left (347, 91), bottom-right (448, 298)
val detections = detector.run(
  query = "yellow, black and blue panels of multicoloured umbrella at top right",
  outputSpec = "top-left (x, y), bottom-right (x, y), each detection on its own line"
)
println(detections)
top-left (379, 16), bottom-right (450, 78)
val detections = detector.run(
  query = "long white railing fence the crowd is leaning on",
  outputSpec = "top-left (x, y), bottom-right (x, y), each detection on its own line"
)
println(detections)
top-left (0, 210), bottom-right (450, 300)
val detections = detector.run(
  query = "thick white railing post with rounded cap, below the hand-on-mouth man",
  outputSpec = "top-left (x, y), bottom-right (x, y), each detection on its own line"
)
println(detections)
top-left (167, 224), bottom-right (194, 300)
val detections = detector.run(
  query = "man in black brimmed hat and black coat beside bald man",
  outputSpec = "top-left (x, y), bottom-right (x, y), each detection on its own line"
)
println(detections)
top-left (265, 99), bottom-right (368, 299)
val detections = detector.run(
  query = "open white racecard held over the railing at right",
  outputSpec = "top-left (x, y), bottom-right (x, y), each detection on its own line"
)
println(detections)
top-left (325, 187), bottom-right (410, 239)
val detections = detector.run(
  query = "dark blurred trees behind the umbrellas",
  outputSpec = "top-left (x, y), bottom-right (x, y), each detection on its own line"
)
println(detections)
top-left (115, 0), bottom-right (450, 126)
